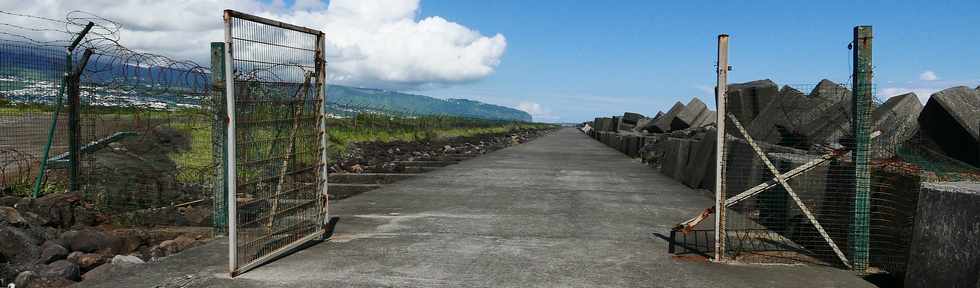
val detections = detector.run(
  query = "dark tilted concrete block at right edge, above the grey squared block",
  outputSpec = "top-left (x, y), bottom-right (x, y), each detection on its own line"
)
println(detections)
top-left (919, 86), bottom-right (980, 167)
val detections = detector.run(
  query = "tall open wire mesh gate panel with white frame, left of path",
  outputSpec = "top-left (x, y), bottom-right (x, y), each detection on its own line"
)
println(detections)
top-left (224, 10), bottom-right (327, 276)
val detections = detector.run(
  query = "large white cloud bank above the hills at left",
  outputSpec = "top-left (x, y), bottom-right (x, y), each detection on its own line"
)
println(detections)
top-left (0, 0), bottom-right (507, 89)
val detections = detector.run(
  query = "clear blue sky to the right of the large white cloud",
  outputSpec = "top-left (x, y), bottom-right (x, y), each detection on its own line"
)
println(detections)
top-left (406, 0), bottom-right (980, 122)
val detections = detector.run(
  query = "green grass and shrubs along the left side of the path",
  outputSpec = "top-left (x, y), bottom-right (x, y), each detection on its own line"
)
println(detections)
top-left (0, 103), bottom-right (552, 195)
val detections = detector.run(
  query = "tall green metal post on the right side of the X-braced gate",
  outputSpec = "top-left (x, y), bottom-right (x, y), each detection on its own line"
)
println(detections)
top-left (848, 26), bottom-right (873, 272)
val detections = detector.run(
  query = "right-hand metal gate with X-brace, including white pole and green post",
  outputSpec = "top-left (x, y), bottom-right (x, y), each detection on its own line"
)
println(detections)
top-left (716, 26), bottom-right (875, 271)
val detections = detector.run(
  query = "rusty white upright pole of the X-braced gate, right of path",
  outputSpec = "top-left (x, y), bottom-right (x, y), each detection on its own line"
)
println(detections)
top-left (714, 34), bottom-right (728, 261)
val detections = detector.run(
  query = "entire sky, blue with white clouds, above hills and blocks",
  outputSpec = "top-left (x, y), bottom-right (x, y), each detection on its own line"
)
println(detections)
top-left (0, 0), bottom-right (980, 122)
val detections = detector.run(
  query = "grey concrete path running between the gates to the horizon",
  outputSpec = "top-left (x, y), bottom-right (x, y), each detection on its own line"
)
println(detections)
top-left (80, 128), bottom-right (872, 288)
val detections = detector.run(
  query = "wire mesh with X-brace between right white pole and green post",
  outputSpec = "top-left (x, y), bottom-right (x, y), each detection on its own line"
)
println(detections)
top-left (724, 81), bottom-right (854, 266)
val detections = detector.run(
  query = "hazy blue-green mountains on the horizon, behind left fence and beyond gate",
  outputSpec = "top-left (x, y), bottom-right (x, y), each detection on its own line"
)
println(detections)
top-left (0, 41), bottom-right (532, 122)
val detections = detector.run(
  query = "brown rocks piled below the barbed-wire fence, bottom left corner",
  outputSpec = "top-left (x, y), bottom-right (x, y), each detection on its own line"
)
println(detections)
top-left (0, 193), bottom-right (210, 287)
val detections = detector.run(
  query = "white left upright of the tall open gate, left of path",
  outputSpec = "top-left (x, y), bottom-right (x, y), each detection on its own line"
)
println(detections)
top-left (224, 10), bottom-right (238, 277)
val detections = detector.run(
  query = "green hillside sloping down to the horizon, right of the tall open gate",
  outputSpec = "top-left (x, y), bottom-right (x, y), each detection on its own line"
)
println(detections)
top-left (327, 85), bottom-right (531, 122)
